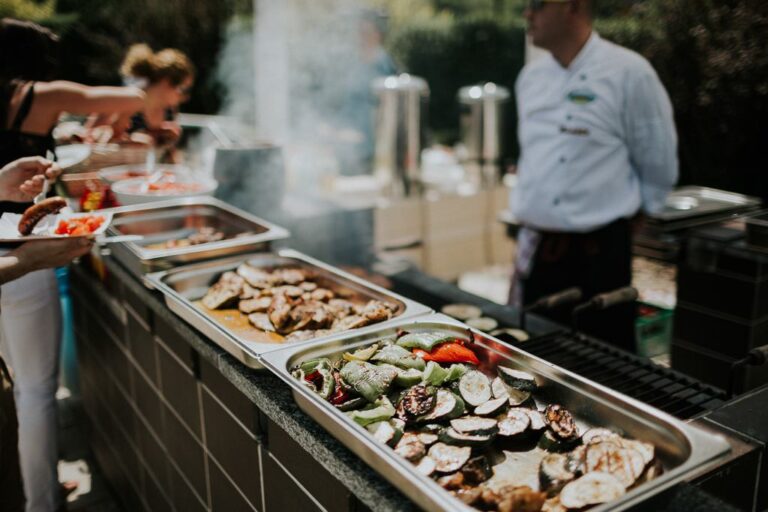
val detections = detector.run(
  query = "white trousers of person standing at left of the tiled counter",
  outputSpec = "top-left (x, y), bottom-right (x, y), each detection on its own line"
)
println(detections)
top-left (0, 270), bottom-right (61, 512)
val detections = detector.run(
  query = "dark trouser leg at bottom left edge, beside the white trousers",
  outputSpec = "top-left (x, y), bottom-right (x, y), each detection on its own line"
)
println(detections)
top-left (0, 358), bottom-right (24, 512)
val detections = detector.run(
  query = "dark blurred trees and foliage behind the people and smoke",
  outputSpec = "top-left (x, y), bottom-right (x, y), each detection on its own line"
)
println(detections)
top-left (0, 0), bottom-right (768, 197)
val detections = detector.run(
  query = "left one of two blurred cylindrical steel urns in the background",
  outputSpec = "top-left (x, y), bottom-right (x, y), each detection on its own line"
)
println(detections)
top-left (371, 73), bottom-right (429, 197)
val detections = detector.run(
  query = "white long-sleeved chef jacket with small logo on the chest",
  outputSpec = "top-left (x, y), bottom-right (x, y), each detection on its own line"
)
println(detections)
top-left (511, 32), bottom-right (678, 232)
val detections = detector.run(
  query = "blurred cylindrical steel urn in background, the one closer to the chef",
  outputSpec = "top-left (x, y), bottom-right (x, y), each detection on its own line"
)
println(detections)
top-left (458, 82), bottom-right (509, 187)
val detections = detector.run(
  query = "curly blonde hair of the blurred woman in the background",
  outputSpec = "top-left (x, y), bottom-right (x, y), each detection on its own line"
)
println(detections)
top-left (120, 44), bottom-right (195, 86)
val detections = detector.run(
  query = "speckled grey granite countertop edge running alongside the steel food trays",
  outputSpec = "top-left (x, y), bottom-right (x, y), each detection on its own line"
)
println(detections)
top-left (73, 257), bottom-right (730, 512)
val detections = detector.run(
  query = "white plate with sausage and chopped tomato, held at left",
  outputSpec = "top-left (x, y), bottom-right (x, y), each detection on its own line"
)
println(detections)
top-left (0, 196), bottom-right (112, 243)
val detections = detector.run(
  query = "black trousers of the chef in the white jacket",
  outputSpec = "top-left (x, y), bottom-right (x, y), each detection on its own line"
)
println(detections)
top-left (522, 219), bottom-right (636, 352)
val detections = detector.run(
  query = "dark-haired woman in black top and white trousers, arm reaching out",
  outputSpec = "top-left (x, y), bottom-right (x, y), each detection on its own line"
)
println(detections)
top-left (0, 18), bottom-right (147, 512)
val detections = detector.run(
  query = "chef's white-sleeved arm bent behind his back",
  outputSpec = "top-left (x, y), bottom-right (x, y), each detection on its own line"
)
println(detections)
top-left (624, 63), bottom-right (678, 213)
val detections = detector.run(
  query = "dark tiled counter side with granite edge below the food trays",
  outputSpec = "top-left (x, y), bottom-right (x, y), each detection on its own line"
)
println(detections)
top-left (71, 258), bottom-right (408, 512)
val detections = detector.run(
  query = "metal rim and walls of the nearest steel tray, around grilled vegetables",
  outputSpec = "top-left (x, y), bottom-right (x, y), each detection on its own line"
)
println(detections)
top-left (262, 315), bottom-right (730, 511)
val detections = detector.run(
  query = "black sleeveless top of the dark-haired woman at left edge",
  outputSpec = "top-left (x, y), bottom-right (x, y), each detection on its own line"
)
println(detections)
top-left (0, 80), bottom-right (55, 213)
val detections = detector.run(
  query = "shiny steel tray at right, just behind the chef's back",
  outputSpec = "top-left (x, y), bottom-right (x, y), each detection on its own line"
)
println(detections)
top-left (650, 186), bottom-right (760, 222)
